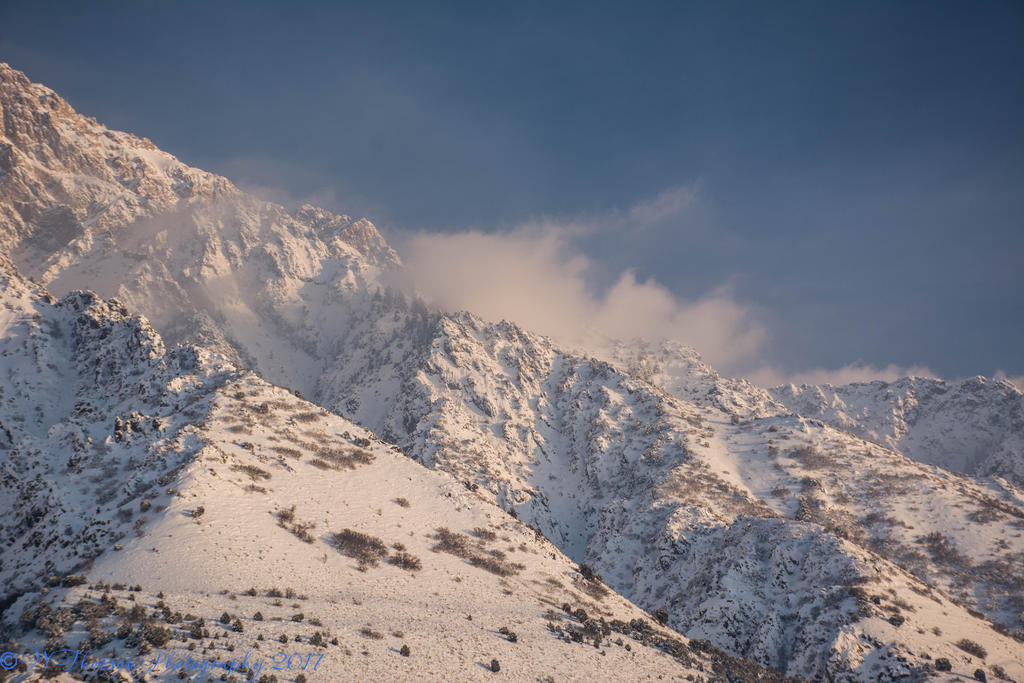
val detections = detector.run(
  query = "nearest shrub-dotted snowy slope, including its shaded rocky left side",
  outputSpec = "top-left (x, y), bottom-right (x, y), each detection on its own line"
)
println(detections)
top-left (0, 269), bottom-right (779, 681)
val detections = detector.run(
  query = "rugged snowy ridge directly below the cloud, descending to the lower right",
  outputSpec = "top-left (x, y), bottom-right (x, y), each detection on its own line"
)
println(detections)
top-left (315, 315), bottom-right (1024, 680)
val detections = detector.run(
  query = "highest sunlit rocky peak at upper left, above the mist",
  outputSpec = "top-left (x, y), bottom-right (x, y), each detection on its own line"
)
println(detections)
top-left (0, 63), bottom-right (400, 273)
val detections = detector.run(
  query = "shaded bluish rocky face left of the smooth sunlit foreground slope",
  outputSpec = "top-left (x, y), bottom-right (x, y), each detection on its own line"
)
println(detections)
top-left (0, 252), bottom-right (234, 595)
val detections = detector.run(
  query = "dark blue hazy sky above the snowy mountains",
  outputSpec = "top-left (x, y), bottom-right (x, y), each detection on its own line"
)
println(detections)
top-left (0, 0), bottom-right (1024, 377)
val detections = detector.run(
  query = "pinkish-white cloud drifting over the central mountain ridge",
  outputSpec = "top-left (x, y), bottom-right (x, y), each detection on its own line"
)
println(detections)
top-left (391, 187), bottom-right (935, 386)
